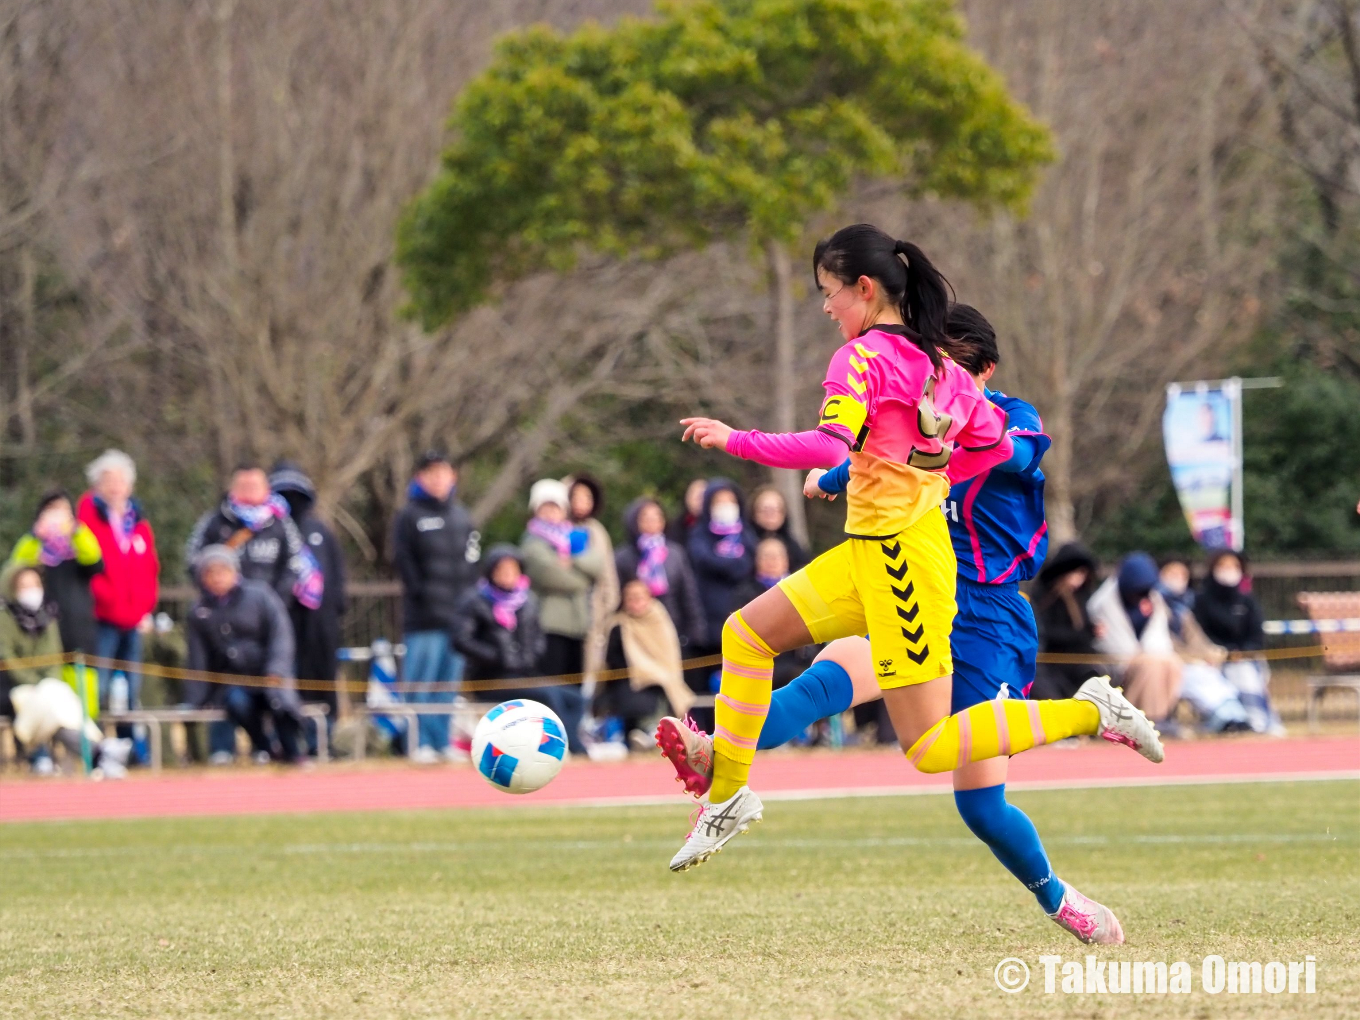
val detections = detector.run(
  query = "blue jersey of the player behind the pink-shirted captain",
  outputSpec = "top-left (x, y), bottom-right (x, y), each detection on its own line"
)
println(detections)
top-left (941, 389), bottom-right (1053, 585)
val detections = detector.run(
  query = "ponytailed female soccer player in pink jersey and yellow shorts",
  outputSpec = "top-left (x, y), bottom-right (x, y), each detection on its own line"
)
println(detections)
top-left (670, 223), bottom-right (1161, 870)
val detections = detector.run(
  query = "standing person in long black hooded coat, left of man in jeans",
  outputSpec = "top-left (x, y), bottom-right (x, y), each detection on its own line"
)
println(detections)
top-left (269, 461), bottom-right (345, 753)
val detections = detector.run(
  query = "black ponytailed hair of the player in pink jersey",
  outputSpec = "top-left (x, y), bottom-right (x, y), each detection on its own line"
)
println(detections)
top-left (812, 223), bottom-right (953, 371)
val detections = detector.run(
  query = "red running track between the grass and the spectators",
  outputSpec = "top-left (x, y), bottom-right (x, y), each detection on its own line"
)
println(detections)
top-left (0, 737), bottom-right (1360, 821)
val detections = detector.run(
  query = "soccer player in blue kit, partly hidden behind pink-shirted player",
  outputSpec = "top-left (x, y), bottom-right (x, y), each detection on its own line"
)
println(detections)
top-left (657, 305), bottom-right (1123, 944)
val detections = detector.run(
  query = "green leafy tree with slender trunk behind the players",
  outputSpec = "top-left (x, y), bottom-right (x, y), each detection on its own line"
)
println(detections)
top-left (397, 0), bottom-right (1053, 538)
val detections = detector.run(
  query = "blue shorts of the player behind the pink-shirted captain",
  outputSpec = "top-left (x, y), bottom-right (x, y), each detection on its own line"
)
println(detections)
top-left (949, 578), bottom-right (1039, 711)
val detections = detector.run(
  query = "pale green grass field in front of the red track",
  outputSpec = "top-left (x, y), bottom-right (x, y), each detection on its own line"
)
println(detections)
top-left (0, 782), bottom-right (1360, 1020)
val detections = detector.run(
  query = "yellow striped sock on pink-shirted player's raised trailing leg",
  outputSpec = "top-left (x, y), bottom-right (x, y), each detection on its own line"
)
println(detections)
top-left (907, 698), bottom-right (1100, 772)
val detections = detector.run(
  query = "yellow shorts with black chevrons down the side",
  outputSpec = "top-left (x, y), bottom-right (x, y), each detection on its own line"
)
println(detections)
top-left (779, 513), bottom-right (957, 691)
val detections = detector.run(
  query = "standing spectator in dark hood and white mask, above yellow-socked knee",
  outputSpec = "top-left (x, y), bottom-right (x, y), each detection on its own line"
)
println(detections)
top-left (690, 479), bottom-right (759, 653)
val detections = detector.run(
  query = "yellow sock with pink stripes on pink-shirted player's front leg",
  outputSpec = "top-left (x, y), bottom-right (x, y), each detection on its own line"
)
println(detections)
top-left (709, 611), bottom-right (774, 804)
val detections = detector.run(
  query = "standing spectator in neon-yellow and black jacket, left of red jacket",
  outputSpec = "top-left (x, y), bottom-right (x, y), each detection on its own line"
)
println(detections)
top-left (7, 488), bottom-right (103, 719)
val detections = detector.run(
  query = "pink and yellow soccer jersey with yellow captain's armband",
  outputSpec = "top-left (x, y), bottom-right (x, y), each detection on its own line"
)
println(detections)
top-left (817, 325), bottom-right (1009, 539)
